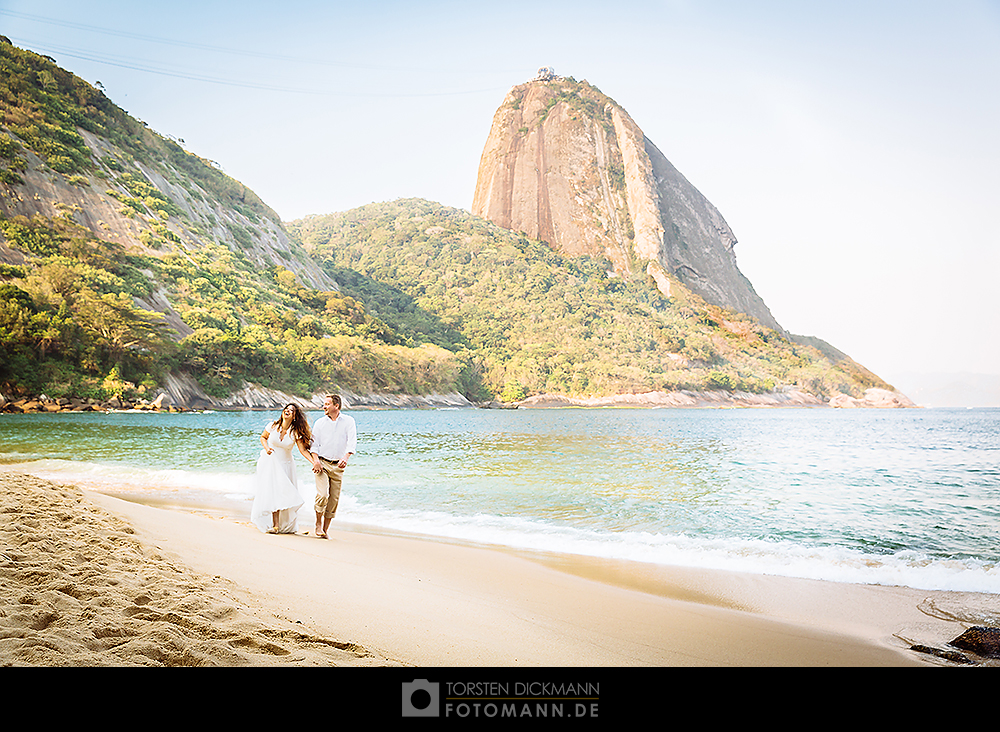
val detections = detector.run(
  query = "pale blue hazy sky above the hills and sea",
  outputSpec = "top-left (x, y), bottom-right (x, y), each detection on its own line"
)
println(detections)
top-left (0, 0), bottom-right (1000, 382)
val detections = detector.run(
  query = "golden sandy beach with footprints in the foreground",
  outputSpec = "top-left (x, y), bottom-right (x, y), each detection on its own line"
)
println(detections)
top-left (0, 472), bottom-right (996, 668)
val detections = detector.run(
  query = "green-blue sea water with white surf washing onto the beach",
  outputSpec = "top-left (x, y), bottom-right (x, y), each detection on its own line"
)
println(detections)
top-left (0, 409), bottom-right (1000, 594)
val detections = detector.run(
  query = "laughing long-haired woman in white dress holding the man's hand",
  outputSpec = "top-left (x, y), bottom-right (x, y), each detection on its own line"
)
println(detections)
top-left (250, 404), bottom-right (312, 534)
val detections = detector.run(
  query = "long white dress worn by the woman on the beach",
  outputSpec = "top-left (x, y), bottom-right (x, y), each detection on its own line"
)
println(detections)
top-left (250, 425), bottom-right (305, 534)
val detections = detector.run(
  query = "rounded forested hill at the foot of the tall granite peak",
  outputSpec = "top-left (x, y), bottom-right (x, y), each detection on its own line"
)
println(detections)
top-left (288, 199), bottom-right (891, 400)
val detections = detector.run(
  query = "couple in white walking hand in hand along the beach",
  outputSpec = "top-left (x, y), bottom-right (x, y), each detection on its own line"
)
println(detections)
top-left (250, 394), bottom-right (357, 539)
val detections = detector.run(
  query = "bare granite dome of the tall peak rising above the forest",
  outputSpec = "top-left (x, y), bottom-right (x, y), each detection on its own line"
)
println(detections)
top-left (472, 74), bottom-right (784, 333)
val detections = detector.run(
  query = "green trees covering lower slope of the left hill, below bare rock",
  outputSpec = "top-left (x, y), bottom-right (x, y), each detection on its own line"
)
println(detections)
top-left (0, 207), bottom-right (475, 398)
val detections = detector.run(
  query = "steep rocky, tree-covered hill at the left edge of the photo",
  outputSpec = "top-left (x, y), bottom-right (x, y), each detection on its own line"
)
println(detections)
top-left (0, 37), bottom-right (476, 405)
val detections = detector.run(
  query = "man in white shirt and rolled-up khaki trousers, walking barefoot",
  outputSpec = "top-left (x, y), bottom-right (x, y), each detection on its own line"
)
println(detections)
top-left (310, 394), bottom-right (358, 539)
